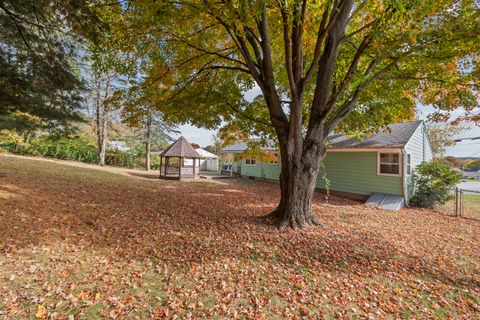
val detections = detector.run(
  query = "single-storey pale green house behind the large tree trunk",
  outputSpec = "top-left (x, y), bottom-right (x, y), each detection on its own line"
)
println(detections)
top-left (220, 121), bottom-right (432, 203)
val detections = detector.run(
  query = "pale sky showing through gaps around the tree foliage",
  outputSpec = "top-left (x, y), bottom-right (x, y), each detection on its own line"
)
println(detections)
top-left (175, 87), bottom-right (480, 157)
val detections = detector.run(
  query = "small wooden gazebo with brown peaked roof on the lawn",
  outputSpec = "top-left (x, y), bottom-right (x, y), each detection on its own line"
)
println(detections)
top-left (160, 137), bottom-right (201, 180)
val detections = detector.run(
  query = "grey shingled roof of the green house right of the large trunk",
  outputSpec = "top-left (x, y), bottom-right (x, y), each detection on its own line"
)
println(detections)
top-left (329, 120), bottom-right (423, 149)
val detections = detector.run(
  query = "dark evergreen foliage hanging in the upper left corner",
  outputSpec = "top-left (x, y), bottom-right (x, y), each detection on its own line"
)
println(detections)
top-left (0, 0), bottom-right (99, 124)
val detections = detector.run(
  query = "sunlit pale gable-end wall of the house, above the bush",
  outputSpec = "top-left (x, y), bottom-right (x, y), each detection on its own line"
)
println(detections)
top-left (405, 125), bottom-right (432, 197)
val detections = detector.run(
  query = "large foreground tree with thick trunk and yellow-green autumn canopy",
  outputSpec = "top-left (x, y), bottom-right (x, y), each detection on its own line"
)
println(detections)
top-left (115, 0), bottom-right (480, 229)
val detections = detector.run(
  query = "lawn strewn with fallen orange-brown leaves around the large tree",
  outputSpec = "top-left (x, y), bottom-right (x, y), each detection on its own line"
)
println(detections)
top-left (0, 155), bottom-right (480, 319)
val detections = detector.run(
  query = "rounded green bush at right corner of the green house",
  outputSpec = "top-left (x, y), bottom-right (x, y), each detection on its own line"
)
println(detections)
top-left (412, 161), bottom-right (462, 209)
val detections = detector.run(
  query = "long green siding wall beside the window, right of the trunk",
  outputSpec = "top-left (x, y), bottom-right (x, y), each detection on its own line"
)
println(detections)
top-left (317, 151), bottom-right (403, 195)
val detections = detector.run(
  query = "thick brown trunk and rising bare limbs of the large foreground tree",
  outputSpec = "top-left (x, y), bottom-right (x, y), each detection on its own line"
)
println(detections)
top-left (202, 0), bottom-right (356, 229)
